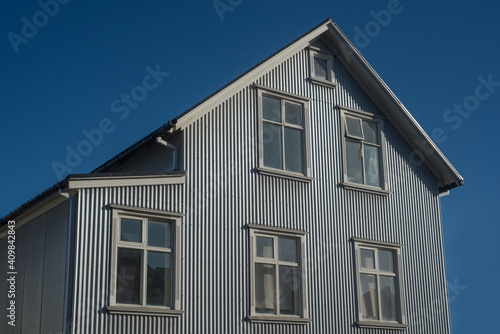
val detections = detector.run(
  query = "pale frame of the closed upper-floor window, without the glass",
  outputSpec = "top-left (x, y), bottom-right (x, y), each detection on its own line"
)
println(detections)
top-left (255, 85), bottom-right (313, 182)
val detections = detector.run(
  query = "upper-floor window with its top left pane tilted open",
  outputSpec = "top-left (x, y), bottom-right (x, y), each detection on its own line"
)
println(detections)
top-left (342, 110), bottom-right (387, 194)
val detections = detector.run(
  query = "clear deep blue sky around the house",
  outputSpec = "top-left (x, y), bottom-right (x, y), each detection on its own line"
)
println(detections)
top-left (0, 0), bottom-right (500, 334)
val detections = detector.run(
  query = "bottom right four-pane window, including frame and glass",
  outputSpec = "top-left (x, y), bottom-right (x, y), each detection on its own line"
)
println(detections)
top-left (355, 239), bottom-right (406, 328)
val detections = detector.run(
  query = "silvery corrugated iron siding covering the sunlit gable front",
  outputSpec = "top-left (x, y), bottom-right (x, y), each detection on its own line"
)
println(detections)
top-left (74, 50), bottom-right (450, 334)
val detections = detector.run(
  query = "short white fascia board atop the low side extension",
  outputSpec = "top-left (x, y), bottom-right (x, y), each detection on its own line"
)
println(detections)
top-left (68, 175), bottom-right (186, 189)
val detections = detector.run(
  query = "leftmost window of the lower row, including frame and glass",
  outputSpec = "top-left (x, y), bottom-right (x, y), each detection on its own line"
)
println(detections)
top-left (109, 204), bottom-right (180, 312)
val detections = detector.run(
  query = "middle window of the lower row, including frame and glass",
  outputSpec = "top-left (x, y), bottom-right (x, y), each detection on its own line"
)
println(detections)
top-left (250, 225), bottom-right (309, 323)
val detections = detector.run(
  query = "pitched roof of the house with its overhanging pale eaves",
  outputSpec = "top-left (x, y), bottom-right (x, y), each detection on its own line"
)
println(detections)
top-left (0, 18), bottom-right (464, 226)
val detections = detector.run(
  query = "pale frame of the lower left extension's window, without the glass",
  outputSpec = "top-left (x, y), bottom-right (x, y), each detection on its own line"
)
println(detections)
top-left (107, 204), bottom-right (183, 317)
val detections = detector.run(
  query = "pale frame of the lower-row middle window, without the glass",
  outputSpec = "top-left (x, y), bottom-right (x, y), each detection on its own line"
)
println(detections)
top-left (247, 224), bottom-right (311, 324)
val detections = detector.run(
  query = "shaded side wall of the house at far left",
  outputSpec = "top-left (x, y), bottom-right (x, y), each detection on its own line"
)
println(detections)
top-left (0, 201), bottom-right (69, 334)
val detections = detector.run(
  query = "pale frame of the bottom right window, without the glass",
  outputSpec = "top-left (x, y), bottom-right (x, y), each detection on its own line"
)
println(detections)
top-left (352, 238), bottom-right (409, 330)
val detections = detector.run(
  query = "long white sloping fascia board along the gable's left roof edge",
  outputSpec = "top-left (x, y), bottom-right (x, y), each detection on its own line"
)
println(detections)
top-left (174, 23), bottom-right (330, 131)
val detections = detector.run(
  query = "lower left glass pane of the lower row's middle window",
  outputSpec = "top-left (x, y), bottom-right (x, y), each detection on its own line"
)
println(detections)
top-left (255, 263), bottom-right (276, 313)
